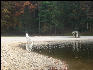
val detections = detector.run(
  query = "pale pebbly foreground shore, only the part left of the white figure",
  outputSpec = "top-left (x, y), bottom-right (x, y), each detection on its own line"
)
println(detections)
top-left (1, 37), bottom-right (68, 70)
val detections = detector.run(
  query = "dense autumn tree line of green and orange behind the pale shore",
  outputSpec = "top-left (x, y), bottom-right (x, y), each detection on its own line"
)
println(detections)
top-left (1, 1), bottom-right (93, 35)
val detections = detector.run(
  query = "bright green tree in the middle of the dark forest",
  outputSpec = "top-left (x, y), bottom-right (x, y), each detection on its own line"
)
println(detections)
top-left (39, 1), bottom-right (59, 32)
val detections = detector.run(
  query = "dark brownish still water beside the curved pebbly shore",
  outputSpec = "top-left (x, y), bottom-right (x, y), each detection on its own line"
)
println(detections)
top-left (33, 42), bottom-right (93, 70)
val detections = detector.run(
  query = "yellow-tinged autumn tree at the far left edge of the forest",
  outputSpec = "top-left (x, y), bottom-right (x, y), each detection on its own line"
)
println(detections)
top-left (1, 1), bottom-right (15, 32)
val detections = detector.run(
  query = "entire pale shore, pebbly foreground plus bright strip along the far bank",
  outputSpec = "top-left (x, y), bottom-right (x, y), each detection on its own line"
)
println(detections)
top-left (1, 36), bottom-right (93, 70)
